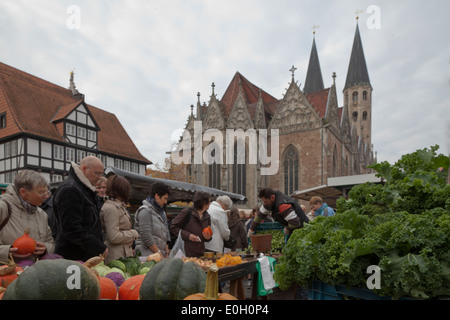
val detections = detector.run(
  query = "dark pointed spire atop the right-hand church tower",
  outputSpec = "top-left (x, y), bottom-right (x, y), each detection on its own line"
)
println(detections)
top-left (344, 19), bottom-right (370, 90)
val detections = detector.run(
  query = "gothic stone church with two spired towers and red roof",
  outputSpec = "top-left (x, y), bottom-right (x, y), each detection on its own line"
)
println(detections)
top-left (171, 25), bottom-right (376, 207)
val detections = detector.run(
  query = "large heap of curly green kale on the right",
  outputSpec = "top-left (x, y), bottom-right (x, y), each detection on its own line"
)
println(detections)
top-left (274, 146), bottom-right (450, 299)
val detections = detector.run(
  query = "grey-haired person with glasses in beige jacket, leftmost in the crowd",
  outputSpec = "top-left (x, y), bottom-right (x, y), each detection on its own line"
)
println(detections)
top-left (0, 170), bottom-right (55, 262)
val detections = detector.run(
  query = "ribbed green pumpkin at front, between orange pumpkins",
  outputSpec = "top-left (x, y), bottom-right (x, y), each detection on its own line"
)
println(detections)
top-left (139, 258), bottom-right (206, 300)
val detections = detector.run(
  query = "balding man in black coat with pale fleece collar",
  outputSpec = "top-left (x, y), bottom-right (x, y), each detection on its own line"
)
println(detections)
top-left (53, 156), bottom-right (108, 261)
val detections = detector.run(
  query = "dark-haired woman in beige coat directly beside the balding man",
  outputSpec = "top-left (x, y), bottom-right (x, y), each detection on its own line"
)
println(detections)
top-left (100, 175), bottom-right (139, 264)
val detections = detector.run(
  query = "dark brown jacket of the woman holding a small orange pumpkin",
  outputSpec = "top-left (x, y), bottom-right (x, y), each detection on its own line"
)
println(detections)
top-left (170, 208), bottom-right (211, 257)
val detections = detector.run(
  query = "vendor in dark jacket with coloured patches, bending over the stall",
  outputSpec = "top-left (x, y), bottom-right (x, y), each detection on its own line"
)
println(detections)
top-left (248, 188), bottom-right (309, 236)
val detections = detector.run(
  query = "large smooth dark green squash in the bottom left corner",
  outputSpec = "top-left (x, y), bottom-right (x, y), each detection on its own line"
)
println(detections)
top-left (2, 259), bottom-right (100, 300)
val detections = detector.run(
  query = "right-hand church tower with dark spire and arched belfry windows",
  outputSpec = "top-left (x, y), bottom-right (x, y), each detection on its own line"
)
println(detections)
top-left (343, 18), bottom-right (373, 148)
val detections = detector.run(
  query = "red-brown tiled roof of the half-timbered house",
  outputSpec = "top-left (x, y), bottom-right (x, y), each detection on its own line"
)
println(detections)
top-left (0, 62), bottom-right (151, 164)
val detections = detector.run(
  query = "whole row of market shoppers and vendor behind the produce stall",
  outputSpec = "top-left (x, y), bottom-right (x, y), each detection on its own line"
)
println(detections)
top-left (0, 156), bottom-right (334, 263)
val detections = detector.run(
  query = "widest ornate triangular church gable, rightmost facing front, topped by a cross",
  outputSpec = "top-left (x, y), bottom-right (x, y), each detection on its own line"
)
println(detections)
top-left (269, 82), bottom-right (321, 134)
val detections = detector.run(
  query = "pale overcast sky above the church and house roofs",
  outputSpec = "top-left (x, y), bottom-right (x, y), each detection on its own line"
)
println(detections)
top-left (0, 0), bottom-right (450, 170)
